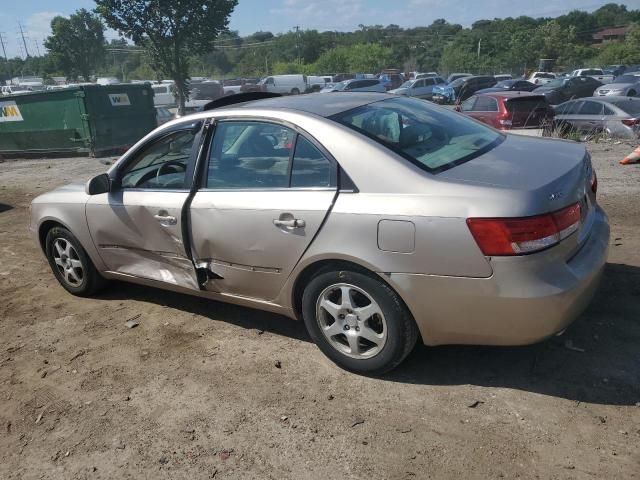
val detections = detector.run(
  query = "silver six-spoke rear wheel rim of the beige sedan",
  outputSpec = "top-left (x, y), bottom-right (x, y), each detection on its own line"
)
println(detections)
top-left (316, 284), bottom-right (387, 359)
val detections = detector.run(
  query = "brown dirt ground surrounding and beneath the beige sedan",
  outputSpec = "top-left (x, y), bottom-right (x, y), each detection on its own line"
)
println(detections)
top-left (0, 143), bottom-right (640, 479)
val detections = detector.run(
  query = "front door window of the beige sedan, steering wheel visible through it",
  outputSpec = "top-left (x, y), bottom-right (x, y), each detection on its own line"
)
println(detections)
top-left (122, 130), bottom-right (195, 190)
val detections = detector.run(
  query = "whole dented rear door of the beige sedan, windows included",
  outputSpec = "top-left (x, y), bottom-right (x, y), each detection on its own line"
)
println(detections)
top-left (190, 120), bottom-right (337, 301)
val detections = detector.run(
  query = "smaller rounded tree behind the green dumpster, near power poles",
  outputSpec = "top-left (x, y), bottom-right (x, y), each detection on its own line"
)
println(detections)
top-left (44, 8), bottom-right (105, 81)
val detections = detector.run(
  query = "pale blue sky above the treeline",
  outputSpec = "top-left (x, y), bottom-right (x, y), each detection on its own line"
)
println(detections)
top-left (0, 0), bottom-right (640, 57)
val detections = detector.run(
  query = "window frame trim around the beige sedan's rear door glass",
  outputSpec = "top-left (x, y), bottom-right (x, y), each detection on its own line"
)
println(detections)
top-left (197, 115), bottom-right (342, 192)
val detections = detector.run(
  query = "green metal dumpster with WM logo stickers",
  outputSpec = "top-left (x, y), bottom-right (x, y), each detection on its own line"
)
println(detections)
top-left (0, 84), bottom-right (157, 156)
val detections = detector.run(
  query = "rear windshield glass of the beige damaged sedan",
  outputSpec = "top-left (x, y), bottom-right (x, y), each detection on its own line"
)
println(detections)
top-left (332, 98), bottom-right (504, 173)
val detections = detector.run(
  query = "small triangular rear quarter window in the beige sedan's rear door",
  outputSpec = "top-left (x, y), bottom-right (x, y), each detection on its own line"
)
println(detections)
top-left (291, 136), bottom-right (337, 188)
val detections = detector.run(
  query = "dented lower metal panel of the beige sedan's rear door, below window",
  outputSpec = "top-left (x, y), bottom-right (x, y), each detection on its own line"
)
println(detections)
top-left (191, 189), bottom-right (336, 300)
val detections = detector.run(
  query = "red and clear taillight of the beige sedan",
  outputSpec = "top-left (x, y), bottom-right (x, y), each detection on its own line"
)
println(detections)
top-left (467, 203), bottom-right (581, 256)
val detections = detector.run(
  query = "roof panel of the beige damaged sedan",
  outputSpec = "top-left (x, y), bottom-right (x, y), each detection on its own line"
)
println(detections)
top-left (230, 92), bottom-right (390, 117)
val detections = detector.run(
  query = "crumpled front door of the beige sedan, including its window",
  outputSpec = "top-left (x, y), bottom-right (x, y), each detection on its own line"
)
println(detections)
top-left (86, 123), bottom-right (199, 289)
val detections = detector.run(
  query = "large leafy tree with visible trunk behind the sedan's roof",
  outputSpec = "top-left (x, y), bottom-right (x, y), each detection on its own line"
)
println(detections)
top-left (96, 0), bottom-right (238, 113)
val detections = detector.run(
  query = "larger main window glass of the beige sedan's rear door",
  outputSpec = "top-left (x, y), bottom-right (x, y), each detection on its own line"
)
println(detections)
top-left (207, 122), bottom-right (295, 189)
